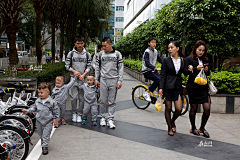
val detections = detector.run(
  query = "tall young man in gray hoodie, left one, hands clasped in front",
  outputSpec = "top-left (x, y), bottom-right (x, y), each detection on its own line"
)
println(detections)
top-left (65, 36), bottom-right (92, 122)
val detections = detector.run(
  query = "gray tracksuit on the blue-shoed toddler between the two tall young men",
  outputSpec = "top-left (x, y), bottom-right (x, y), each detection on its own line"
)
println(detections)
top-left (79, 83), bottom-right (99, 121)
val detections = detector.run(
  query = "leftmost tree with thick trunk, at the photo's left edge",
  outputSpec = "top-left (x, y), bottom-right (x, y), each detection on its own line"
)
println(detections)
top-left (0, 0), bottom-right (23, 76)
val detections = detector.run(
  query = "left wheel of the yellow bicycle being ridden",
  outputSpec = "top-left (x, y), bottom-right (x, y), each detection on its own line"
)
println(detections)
top-left (132, 85), bottom-right (150, 110)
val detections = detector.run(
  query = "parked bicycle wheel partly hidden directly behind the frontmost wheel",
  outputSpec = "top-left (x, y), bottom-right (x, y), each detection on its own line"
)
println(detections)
top-left (0, 115), bottom-right (31, 134)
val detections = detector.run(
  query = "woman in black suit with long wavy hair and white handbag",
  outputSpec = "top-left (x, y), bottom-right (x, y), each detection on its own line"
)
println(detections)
top-left (185, 40), bottom-right (210, 138)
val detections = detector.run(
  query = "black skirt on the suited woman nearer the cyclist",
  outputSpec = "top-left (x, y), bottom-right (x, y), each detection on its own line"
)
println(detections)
top-left (163, 88), bottom-right (182, 101)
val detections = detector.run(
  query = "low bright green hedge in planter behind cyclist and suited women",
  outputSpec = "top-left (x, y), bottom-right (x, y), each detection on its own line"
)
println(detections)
top-left (123, 59), bottom-right (240, 94)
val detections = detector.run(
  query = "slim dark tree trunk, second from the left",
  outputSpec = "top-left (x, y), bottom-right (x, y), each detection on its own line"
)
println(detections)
top-left (36, 10), bottom-right (42, 65)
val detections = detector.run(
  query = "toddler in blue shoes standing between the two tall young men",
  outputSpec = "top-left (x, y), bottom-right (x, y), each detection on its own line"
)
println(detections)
top-left (79, 74), bottom-right (98, 126)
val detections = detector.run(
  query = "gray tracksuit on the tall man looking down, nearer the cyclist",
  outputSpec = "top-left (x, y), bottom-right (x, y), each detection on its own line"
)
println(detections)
top-left (95, 48), bottom-right (123, 119)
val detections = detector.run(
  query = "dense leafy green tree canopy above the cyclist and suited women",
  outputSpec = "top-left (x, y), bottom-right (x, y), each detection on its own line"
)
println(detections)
top-left (115, 0), bottom-right (240, 68)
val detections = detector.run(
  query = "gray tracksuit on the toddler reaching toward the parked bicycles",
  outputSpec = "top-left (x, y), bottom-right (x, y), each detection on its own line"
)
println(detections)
top-left (27, 96), bottom-right (59, 147)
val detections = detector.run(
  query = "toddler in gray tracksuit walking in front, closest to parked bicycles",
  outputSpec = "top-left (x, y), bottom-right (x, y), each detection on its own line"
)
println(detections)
top-left (22, 82), bottom-right (59, 155)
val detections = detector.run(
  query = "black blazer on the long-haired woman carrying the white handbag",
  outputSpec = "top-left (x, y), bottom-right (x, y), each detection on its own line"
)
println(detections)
top-left (184, 56), bottom-right (210, 89)
